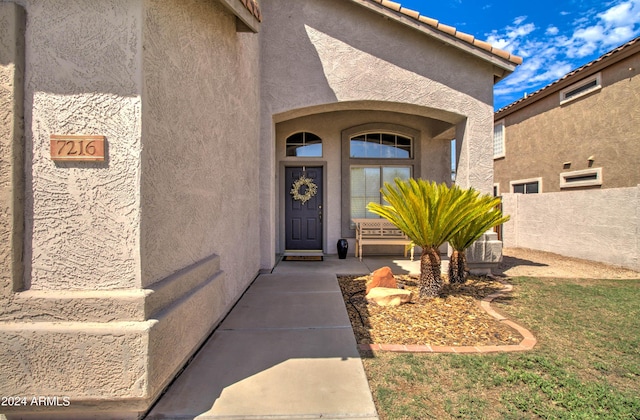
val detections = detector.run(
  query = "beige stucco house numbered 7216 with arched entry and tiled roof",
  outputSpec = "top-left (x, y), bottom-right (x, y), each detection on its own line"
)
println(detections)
top-left (0, 0), bottom-right (521, 418)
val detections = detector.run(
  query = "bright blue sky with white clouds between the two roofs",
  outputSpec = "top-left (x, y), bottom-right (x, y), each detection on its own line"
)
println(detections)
top-left (395, 0), bottom-right (640, 110)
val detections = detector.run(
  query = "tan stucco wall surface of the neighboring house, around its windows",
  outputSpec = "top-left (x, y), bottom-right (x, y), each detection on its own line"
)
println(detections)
top-left (494, 53), bottom-right (640, 192)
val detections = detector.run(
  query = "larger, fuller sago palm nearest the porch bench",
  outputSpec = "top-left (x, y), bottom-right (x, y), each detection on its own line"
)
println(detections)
top-left (367, 179), bottom-right (482, 297)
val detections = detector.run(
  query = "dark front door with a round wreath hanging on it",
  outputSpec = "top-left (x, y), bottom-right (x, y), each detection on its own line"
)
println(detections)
top-left (284, 166), bottom-right (323, 251)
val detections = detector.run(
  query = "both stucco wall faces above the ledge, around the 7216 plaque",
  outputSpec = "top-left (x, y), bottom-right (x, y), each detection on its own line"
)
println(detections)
top-left (3, 0), bottom-right (259, 292)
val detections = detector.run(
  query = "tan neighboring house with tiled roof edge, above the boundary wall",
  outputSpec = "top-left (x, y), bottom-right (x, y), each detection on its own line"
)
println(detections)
top-left (493, 38), bottom-right (640, 195)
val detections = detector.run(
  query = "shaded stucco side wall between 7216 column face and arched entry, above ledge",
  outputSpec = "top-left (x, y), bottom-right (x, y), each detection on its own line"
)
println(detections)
top-left (140, 0), bottom-right (259, 294)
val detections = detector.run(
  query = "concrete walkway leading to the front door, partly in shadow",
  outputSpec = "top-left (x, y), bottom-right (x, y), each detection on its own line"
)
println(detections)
top-left (146, 256), bottom-right (419, 419)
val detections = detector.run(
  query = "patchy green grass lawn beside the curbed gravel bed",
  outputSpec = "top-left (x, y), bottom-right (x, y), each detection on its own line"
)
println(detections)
top-left (363, 278), bottom-right (640, 419)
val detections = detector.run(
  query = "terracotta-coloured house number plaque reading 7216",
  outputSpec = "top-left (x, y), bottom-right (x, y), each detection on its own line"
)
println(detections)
top-left (51, 134), bottom-right (105, 162)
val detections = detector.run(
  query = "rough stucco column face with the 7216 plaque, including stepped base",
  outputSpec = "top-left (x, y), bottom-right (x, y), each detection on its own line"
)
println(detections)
top-left (0, 0), bottom-right (152, 418)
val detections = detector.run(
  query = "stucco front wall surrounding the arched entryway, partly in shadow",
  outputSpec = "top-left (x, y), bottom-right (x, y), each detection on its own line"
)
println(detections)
top-left (260, 0), bottom-right (493, 267)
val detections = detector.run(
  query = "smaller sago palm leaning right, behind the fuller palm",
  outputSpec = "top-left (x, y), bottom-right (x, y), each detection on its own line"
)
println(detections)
top-left (449, 192), bottom-right (509, 283)
